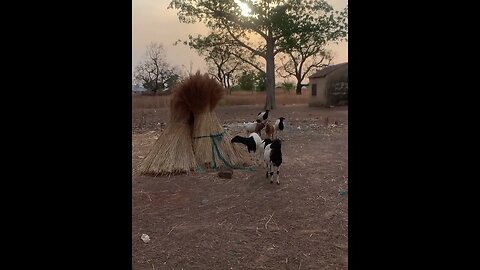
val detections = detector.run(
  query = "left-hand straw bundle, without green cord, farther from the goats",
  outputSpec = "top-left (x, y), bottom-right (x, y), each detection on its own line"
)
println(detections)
top-left (140, 81), bottom-right (196, 176)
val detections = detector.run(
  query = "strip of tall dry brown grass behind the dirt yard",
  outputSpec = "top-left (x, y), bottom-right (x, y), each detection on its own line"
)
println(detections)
top-left (132, 90), bottom-right (310, 109)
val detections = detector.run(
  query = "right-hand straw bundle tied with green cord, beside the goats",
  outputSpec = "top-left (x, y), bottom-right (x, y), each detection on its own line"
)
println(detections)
top-left (179, 72), bottom-right (251, 168)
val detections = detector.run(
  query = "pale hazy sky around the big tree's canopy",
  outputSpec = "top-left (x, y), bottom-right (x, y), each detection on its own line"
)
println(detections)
top-left (132, 0), bottom-right (348, 81)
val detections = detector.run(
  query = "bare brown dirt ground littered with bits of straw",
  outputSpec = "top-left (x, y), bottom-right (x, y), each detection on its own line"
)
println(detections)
top-left (132, 105), bottom-right (348, 269)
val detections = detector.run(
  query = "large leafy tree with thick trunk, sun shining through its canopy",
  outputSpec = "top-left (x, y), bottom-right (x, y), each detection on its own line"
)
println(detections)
top-left (169, 0), bottom-right (343, 110)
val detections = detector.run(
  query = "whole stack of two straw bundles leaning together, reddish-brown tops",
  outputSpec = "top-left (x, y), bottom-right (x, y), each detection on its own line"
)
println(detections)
top-left (140, 72), bottom-right (252, 176)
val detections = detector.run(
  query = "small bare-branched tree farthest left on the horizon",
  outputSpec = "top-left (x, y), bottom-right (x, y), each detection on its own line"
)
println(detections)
top-left (134, 43), bottom-right (181, 93)
